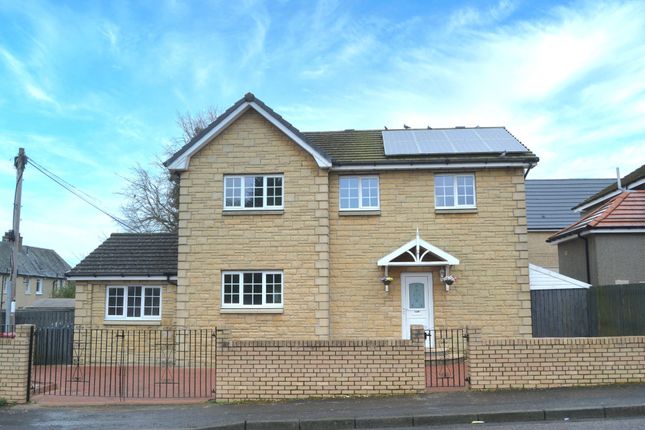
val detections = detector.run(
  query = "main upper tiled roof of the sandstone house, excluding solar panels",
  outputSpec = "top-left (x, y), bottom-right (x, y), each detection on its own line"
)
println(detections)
top-left (164, 93), bottom-right (539, 170)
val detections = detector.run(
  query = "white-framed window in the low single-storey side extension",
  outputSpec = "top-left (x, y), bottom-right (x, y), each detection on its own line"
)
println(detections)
top-left (105, 286), bottom-right (161, 320)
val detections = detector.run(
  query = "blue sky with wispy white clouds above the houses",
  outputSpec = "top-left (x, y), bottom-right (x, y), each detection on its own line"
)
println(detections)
top-left (0, 0), bottom-right (645, 265)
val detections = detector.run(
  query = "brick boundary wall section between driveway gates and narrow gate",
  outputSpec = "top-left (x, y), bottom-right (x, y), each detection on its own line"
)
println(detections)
top-left (216, 326), bottom-right (426, 401)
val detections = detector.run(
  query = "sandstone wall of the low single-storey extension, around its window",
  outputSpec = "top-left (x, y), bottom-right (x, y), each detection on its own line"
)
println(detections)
top-left (74, 281), bottom-right (177, 328)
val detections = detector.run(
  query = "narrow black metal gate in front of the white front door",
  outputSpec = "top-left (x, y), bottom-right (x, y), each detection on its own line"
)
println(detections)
top-left (425, 328), bottom-right (469, 388)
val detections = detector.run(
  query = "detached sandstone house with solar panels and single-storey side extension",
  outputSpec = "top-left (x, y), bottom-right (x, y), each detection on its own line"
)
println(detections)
top-left (68, 93), bottom-right (538, 339)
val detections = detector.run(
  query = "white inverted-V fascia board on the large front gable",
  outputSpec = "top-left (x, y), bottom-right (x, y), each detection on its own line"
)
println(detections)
top-left (168, 102), bottom-right (331, 170)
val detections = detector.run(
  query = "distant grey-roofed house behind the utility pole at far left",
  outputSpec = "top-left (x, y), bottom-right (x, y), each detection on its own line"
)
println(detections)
top-left (0, 233), bottom-right (70, 309)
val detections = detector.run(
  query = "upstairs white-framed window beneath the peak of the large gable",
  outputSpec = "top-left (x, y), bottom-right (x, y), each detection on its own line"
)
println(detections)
top-left (224, 175), bottom-right (284, 209)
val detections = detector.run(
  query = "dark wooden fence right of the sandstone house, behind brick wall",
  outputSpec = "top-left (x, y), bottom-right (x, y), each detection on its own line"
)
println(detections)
top-left (531, 284), bottom-right (645, 337)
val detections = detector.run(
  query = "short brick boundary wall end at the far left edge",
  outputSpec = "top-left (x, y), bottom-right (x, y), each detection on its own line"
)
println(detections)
top-left (0, 324), bottom-right (32, 403)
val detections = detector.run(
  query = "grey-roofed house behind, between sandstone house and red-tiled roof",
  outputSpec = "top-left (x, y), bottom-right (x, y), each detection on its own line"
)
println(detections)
top-left (526, 179), bottom-right (616, 272)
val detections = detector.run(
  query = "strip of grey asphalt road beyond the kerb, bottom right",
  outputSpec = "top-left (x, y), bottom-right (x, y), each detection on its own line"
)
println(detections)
top-left (374, 417), bottom-right (645, 430)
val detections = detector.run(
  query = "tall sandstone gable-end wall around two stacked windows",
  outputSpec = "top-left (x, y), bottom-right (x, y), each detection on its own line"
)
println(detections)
top-left (177, 110), bottom-right (329, 339)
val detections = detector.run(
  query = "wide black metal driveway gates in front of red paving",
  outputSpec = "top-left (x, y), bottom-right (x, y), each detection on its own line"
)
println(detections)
top-left (31, 327), bottom-right (217, 399)
